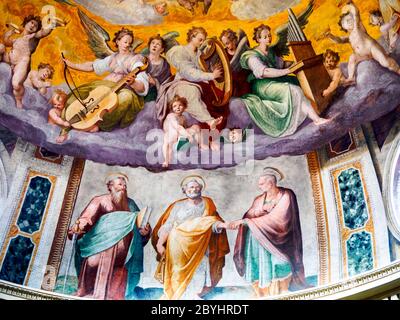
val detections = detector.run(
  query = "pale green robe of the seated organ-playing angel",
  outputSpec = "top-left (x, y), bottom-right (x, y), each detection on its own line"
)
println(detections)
top-left (240, 49), bottom-right (299, 137)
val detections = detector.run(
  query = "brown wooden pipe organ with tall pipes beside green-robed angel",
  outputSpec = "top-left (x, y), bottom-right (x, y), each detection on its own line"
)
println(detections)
top-left (287, 9), bottom-right (332, 114)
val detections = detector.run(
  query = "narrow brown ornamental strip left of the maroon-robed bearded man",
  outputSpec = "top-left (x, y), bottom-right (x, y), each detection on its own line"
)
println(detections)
top-left (42, 158), bottom-right (85, 291)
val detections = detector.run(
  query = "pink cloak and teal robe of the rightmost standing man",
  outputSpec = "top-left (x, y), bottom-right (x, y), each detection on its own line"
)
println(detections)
top-left (234, 188), bottom-right (307, 287)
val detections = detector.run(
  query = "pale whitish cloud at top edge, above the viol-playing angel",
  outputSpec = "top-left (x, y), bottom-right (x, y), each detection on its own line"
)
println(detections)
top-left (75, 0), bottom-right (163, 25)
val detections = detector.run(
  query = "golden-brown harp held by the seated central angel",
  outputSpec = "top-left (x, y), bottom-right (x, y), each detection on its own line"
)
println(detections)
top-left (199, 38), bottom-right (233, 107)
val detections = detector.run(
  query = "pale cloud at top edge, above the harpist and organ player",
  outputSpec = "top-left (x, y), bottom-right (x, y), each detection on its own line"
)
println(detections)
top-left (231, 0), bottom-right (300, 20)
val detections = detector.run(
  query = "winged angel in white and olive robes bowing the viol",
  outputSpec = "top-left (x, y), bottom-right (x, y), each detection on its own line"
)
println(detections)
top-left (57, 11), bottom-right (149, 143)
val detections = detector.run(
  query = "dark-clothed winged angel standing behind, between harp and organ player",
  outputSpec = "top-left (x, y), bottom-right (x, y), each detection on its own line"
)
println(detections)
top-left (219, 29), bottom-right (250, 97)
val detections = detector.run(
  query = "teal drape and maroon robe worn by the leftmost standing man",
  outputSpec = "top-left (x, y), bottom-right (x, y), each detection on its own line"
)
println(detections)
top-left (75, 199), bottom-right (144, 300)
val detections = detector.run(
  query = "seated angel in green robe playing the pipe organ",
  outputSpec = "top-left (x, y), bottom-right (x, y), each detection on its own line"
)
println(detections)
top-left (240, 1), bottom-right (330, 137)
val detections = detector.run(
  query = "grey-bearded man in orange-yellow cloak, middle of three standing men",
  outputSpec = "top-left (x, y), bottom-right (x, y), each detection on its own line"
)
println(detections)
top-left (152, 176), bottom-right (229, 300)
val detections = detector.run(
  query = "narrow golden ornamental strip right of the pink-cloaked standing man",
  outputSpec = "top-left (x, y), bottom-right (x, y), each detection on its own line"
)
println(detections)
top-left (307, 151), bottom-right (331, 284)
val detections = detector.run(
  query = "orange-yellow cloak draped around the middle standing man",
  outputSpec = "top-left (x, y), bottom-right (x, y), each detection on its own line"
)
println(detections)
top-left (152, 197), bottom-right (229, 300)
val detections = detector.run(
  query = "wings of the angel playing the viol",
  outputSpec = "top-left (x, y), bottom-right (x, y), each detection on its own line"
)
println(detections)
top-left (78, 9), bottom-right (143, 59)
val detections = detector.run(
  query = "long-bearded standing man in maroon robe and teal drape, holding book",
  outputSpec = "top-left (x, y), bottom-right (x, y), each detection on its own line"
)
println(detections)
top-left (68, 174), bottom-right (151, 300)
